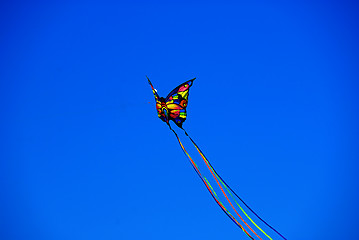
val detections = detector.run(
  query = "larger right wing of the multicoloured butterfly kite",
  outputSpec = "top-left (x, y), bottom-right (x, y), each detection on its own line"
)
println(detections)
top-left (165, 78), bottom-right (196, 128)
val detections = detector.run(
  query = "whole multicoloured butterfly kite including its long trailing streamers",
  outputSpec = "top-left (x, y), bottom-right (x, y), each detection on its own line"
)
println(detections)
top-left (147, 77), bottom-right (286, 240)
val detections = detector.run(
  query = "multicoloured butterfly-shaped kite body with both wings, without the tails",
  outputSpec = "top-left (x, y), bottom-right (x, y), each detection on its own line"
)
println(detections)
top-left (147, 78), bottom-right (195, 128)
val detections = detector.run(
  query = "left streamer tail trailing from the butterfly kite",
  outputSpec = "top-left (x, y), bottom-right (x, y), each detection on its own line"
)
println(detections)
top-left (168, 124), bottom-right (255, 240)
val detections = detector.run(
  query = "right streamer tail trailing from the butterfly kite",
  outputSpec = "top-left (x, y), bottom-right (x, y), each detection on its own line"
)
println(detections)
top-left (181, 128), bottom-right (287, 240)
